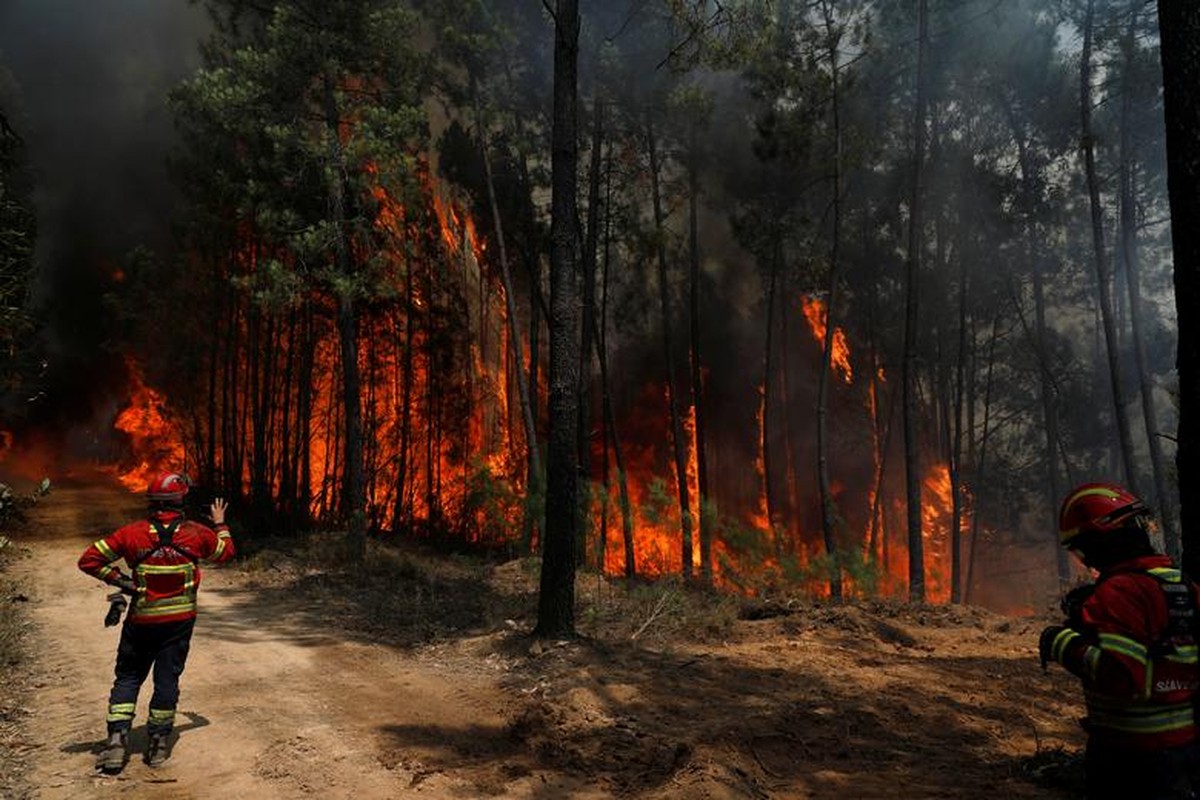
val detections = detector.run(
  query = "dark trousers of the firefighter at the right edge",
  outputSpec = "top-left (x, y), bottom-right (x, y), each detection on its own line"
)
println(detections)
top-left (1084, 741), bottom-right (1200, 800)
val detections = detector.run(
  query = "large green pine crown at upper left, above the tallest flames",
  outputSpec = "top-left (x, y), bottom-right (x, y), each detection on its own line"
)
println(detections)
top-left (172, 0), bottom-right (428, 306)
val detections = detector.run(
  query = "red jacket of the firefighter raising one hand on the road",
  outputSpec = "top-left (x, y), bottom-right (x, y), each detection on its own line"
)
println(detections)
top-left (79, 512), bottom-right (234, 624)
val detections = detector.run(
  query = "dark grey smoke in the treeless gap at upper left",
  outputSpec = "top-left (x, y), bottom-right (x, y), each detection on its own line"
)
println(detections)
top-left (0, 0), bottom-right (206, 431)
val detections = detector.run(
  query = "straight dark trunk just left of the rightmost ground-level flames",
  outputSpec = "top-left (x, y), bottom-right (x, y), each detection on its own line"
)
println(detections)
top-left (902, 0), bottom-right (929, 602)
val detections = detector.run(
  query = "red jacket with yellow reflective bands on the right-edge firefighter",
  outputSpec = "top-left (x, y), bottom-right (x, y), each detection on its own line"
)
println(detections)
top-left (1056, 555), bottom-right (1200, 751)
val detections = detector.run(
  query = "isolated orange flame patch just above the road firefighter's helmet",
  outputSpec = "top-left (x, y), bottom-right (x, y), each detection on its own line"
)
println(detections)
top-left (113, 360), bottom-right (184, 492)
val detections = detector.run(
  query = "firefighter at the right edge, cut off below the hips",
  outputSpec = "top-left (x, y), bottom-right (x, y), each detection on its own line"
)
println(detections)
top-left (1038, 483), bottom-right (1200, 800)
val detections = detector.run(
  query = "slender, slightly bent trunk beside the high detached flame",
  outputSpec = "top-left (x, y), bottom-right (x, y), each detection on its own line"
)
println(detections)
top-left (817, 2), bottom-right (841, 600)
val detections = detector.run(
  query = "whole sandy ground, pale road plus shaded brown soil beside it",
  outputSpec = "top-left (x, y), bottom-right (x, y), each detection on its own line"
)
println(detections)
top-left (0, 481), bottom-right (1082, 800)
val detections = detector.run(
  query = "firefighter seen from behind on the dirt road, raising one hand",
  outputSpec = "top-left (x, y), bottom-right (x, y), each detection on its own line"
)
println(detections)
top-left (79, 473), bottom-right (234, 772)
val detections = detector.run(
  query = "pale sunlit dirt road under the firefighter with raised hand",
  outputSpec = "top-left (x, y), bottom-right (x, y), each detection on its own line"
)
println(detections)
top-left (16, 474), bottom-right (600, 800)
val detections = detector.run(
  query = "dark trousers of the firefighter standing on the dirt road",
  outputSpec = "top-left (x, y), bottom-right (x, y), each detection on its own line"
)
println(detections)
top-left (108, 618), bottom-right (196, 735)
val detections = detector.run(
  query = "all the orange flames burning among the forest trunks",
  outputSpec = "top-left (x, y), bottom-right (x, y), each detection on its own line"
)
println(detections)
top-left (88, 125), bottom-right (950, 599)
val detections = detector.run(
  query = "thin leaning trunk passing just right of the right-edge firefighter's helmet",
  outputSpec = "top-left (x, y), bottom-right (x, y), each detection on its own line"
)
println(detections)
top-left (1120, 2), bottom-right (1180, 558)
